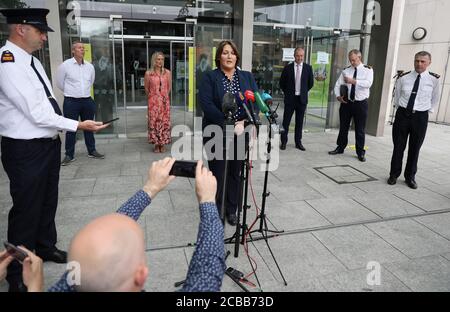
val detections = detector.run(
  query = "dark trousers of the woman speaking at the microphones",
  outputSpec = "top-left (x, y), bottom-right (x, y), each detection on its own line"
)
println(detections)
top-left (203, 130), bottom-right (247, 215)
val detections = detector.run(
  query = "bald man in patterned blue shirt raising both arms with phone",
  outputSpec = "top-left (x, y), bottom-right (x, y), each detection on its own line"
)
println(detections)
top-left (49, 158), bottom-right (225, 292)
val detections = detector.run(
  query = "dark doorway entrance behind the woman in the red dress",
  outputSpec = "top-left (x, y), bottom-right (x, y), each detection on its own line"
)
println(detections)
top-left (110, 17), bottom-right (194, 137)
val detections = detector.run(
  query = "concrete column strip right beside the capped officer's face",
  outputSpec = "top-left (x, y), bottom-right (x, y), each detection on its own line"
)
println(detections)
top-left (46, 0), bottom-right (64, 107)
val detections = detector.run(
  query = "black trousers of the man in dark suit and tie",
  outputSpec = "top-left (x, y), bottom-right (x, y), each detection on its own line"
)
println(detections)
top-left (281, 96), bottom-right (306, 144)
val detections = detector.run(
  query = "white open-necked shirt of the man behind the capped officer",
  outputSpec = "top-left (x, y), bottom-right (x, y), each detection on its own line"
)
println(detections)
top-left (56, 57), bottom-right (95, 98)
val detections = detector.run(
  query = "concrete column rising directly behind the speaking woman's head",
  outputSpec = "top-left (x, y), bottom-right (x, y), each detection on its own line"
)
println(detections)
top-left (233, 0), bottom-right (255, 71)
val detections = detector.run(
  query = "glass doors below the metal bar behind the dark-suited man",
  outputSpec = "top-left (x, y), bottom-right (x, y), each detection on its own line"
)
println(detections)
top-left (252, 22), bottom-right (361, 131)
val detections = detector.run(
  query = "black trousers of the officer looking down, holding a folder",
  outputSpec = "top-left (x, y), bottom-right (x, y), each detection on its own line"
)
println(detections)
top-left (336, 100), bottom-right (368, 156)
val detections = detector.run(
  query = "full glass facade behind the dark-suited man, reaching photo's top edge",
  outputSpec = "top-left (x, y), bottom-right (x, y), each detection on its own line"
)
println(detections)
top-left (252, 0), bottom-right (370, 131)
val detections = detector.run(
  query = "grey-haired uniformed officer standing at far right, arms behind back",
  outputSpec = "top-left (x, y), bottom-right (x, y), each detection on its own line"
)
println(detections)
top-left (388, 51), bottom-right (439, 189)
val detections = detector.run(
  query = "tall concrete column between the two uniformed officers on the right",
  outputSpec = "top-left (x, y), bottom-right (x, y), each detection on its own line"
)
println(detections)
top-left (367, 0), bottom-right (405, 136)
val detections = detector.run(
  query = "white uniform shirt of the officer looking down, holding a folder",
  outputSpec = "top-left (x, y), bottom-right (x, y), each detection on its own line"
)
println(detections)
top-left (334, 63), bottom-right (373, 101)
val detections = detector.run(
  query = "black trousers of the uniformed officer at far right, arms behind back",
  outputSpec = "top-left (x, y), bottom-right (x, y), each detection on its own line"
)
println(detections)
top-left (390, 107), bottom-right (428, 179)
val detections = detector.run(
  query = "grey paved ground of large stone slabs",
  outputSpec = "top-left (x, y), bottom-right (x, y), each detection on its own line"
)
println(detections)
top-left (0, 124), bottom-right (450, 291)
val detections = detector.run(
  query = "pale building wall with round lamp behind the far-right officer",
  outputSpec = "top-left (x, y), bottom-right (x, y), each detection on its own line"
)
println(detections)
top-left (397, 0), bottom-right (450, 123)
